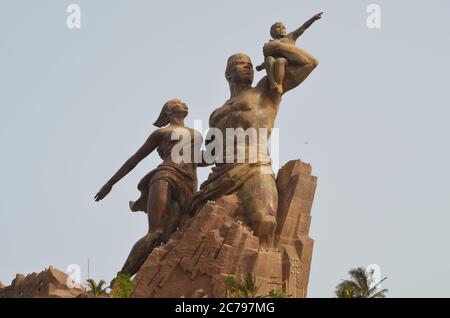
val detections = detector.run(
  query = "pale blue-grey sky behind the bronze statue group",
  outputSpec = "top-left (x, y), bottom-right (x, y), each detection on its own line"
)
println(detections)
top-left (0, 0), bottom-right (450, 297)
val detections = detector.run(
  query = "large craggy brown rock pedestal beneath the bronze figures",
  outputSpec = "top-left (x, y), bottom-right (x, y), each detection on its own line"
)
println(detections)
top-left (133, 161), bottom-right (317, 297)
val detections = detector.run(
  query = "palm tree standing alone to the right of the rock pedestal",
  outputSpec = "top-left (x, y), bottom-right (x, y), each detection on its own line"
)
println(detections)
top-left (335, 267), bottom-right (388, 298)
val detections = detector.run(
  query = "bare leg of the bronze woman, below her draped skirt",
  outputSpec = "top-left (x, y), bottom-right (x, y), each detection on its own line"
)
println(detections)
top-left (120, 180), bottom-right (170, 276)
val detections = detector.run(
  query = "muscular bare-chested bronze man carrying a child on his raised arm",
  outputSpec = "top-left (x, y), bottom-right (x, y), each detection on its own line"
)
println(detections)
top-left (191, 14), bottom-right (321, 248)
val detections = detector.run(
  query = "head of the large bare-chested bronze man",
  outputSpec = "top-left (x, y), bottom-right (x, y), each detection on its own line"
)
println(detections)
top-left (225, 53), bottom-right (253, 85)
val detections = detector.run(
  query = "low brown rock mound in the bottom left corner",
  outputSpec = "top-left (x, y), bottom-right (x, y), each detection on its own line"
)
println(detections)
top-left (0, 267), bottom-right (85, 298)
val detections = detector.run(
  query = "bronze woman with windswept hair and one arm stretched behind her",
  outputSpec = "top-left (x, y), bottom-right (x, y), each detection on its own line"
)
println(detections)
top-left (95, 99), bottom-right (202, 276)
